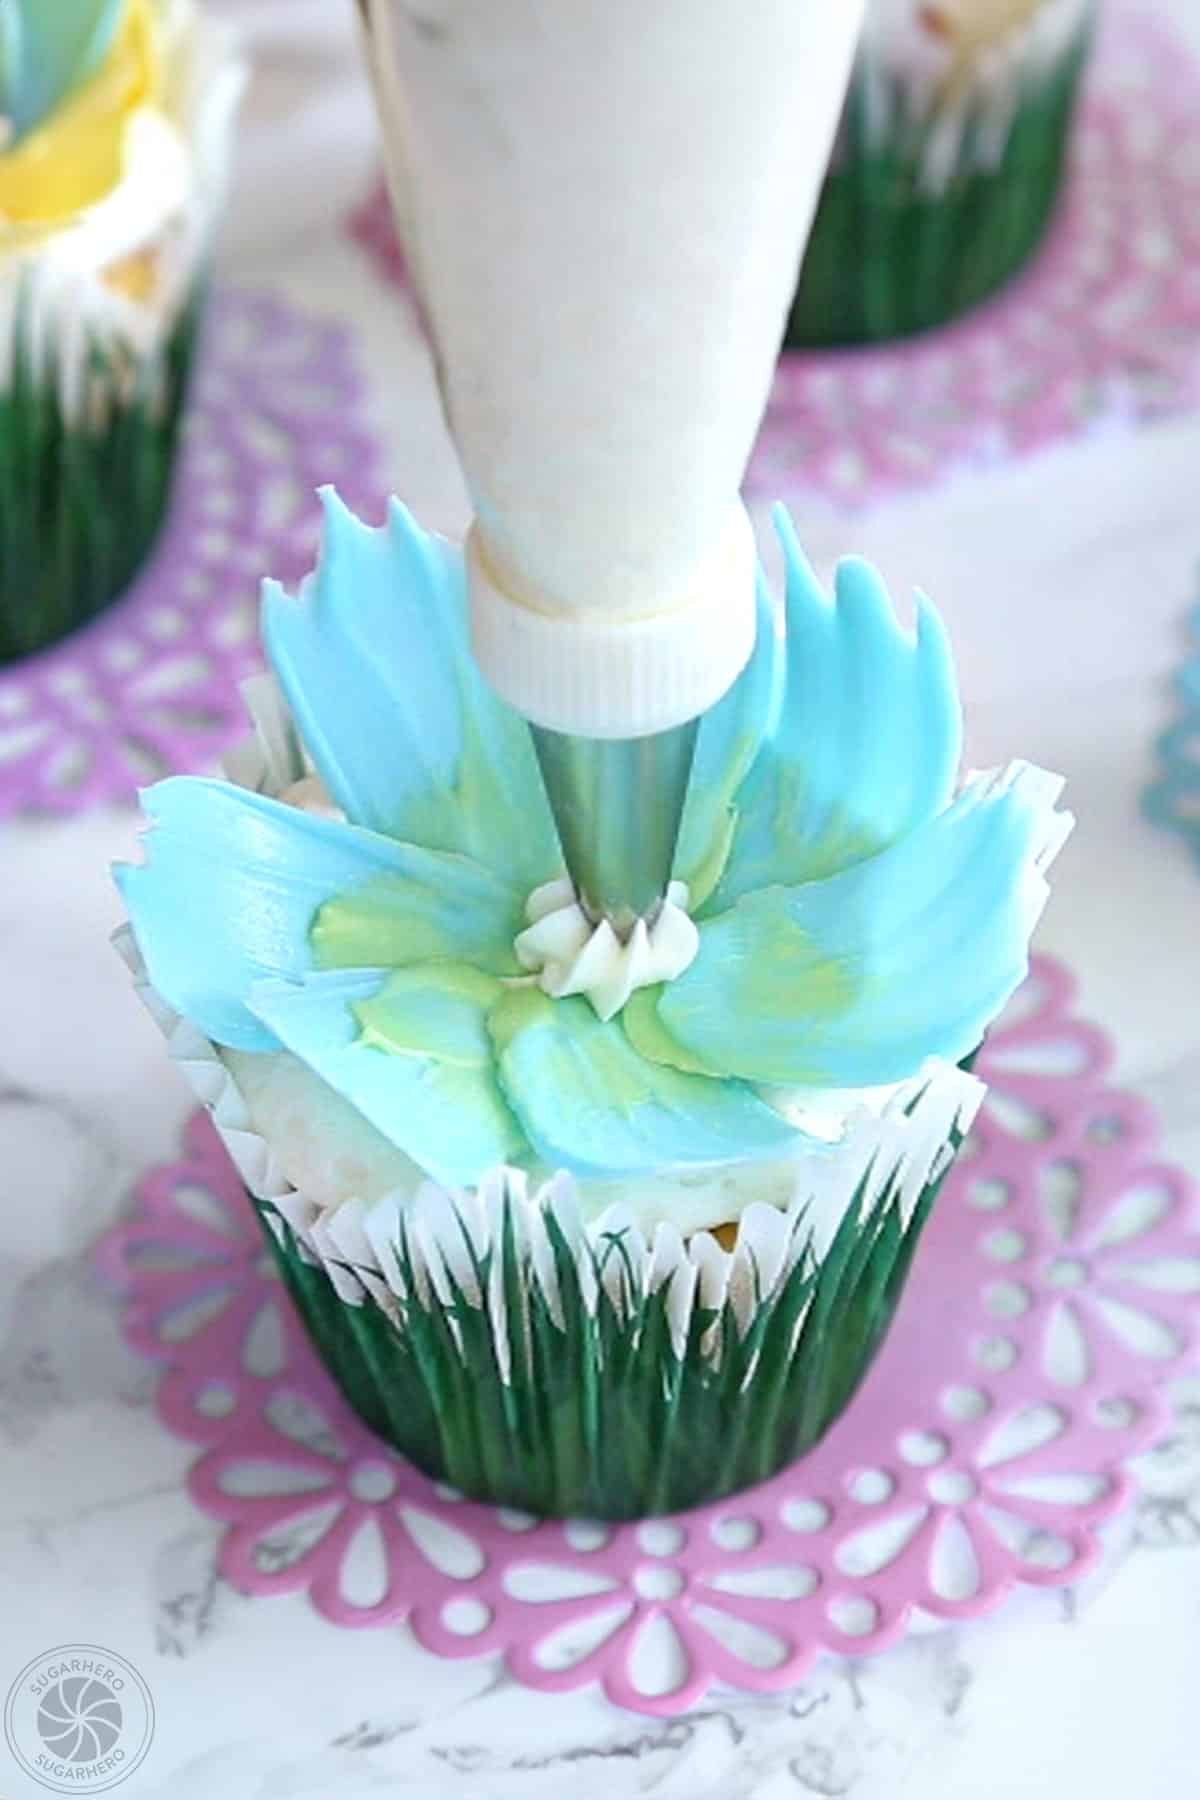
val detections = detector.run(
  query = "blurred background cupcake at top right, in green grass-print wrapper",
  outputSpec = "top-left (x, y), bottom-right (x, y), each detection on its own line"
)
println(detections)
top-left (784, 0), bottom-right (1096, 349)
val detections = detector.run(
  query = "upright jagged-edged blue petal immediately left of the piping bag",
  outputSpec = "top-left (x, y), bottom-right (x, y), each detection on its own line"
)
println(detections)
top-left (263, 490), bottom-right (561, 893)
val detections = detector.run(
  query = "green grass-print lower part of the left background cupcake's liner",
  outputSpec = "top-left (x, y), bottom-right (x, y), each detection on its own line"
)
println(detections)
top-left (0, 283), bottom-right (203, 666)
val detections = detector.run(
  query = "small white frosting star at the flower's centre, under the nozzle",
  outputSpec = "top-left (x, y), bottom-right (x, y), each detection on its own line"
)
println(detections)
top-left (513, 877), bottom-right (700, 1019)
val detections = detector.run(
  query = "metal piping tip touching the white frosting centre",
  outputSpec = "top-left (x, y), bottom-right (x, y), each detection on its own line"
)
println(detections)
top-left (531, 718), bottom-right (700, 941)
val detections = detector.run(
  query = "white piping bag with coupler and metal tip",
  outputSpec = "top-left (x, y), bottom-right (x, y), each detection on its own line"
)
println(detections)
top-left (358, 0), bottom-right (864, 940)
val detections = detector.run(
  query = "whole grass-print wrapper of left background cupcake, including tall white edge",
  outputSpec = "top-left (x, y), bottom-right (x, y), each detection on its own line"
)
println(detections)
top-left (0, 20), bottom-right (245, 666)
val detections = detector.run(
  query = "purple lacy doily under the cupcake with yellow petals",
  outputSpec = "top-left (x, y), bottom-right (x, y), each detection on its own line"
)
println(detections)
top-left (0, 292), bottom-right (381, 819)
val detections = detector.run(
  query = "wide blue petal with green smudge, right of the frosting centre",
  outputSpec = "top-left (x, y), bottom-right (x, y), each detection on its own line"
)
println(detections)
top-left (658, 765), bottom-right (1070, 1087)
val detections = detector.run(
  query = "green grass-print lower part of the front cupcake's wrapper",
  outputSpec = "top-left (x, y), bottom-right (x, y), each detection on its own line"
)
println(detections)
top-left (259, 1154), bottom-right (952, 1519)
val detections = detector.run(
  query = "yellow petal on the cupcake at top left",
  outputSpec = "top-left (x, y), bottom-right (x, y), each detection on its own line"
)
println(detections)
top-left (0, 0), bottom-right (164, 248)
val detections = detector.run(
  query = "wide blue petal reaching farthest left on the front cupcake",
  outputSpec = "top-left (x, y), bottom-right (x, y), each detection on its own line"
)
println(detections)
top-left (115, 776), bottom-right (520, 1049)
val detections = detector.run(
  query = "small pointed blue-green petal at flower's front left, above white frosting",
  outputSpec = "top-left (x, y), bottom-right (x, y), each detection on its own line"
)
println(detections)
top-left (250, 965), bottom-right (525, 1186)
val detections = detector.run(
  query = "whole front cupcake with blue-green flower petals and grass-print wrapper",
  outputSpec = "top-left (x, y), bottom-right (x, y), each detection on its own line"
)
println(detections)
top-left (117, 495), bottom-right (1070, 1517)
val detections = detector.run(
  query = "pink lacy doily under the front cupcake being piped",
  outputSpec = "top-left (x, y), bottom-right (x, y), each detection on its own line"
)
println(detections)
top-left (99, 959), bottom-right (1200, 1715)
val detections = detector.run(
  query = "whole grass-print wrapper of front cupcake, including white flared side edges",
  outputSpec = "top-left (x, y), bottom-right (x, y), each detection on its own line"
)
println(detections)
top-left (117, 914), bottom-right (982, 1519)
